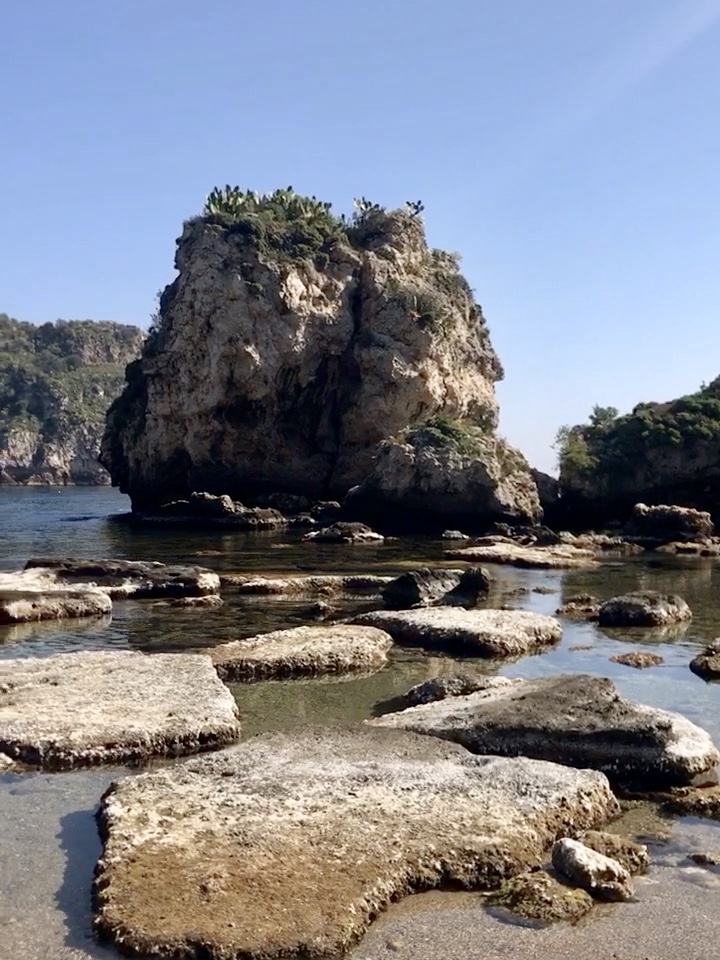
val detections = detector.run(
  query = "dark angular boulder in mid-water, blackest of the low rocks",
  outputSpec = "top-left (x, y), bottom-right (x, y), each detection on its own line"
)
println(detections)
top-left (382, 567), bottom-right (491, 610)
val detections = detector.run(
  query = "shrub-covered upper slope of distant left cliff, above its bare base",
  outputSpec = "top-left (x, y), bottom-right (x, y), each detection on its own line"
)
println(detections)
top-left (0, 313), bottom-right (144, 447)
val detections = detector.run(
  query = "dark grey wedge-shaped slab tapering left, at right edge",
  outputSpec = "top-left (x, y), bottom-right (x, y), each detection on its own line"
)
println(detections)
top-left (368, 674), bottom-right (720, 790)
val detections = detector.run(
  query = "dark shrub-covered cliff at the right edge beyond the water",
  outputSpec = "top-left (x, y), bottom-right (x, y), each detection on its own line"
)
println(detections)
top-left (560, 378), bottom-right (720, 526)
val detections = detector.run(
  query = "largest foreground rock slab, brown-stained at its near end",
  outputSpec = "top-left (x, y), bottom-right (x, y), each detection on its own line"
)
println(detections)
top-left (95, 728), bottom-right (618, 960)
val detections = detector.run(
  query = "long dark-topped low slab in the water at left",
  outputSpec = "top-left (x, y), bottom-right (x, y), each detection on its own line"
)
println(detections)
top-left (25, 557), bottom-right (220, 599)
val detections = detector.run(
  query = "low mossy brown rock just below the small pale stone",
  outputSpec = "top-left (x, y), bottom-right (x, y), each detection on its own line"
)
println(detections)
top-left (488, 870), bottom-right (594, 923)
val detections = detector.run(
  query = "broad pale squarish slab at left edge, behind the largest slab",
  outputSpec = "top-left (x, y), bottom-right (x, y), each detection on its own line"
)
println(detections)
top-left (0, 651), bottom-right (240, 770)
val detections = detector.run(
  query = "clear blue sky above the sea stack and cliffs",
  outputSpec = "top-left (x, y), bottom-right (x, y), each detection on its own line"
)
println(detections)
top-left (0, 0), bottom-right (720, 469)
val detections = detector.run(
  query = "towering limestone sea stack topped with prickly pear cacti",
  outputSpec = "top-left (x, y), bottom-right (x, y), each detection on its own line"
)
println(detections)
top-left (102, 190), bottom-right (538, 517)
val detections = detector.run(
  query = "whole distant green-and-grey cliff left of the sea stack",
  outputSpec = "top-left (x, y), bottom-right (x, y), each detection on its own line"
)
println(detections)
top-left (0, 314), bottom-right (145, 484)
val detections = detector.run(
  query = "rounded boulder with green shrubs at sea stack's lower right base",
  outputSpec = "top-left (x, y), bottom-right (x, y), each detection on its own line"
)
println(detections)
top-left (344, 432), bottom-right (542, 526)
